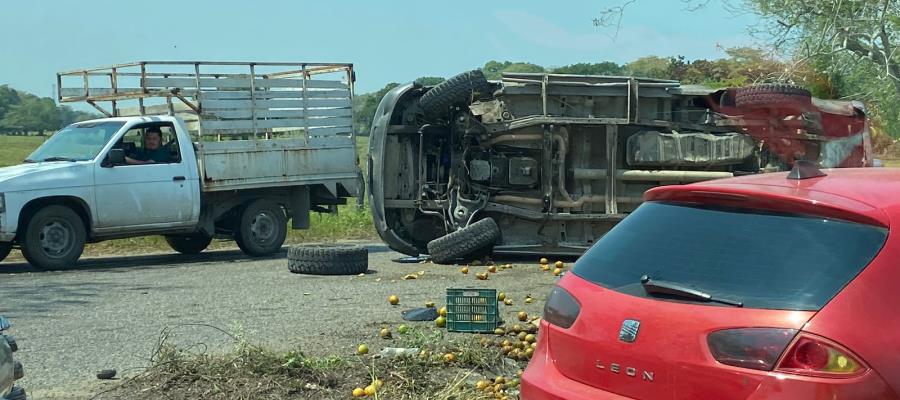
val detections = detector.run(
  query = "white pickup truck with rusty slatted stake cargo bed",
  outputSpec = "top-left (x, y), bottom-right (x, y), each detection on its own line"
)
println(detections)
top-left (0, 62), bottom-right (362, 269)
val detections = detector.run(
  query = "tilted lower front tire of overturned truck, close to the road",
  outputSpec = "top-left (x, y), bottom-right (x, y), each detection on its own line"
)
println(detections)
top-left (428, 218), bottom-right (500, 264)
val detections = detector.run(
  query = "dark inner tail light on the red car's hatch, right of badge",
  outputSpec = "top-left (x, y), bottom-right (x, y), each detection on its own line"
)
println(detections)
top-left (706, 328), bottom-right (797, 371)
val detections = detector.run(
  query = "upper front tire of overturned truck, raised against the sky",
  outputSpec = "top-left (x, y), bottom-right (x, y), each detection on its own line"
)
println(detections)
top-left (419, 69), bottom-right (491, 117)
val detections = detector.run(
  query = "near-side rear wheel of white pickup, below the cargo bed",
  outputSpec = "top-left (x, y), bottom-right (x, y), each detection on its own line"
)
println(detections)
top-left (234, 200), bottom-right (287, 256)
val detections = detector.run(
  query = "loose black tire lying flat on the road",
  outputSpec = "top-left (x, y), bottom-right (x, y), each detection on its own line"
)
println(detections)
top-left (288, 245), bottom-right (369, 275)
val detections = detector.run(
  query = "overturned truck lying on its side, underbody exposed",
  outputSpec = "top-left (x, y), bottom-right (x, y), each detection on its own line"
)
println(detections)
top-left (368, 71), bottom-right (872, 262)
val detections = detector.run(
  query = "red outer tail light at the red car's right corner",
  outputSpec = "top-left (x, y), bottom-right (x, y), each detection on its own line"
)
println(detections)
top-left (776, 333), bottom-right (867, 378)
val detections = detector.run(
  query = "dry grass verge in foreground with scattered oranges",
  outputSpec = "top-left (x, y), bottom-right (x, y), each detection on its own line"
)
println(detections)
top-left (94, 327), bottom-right (523, 400)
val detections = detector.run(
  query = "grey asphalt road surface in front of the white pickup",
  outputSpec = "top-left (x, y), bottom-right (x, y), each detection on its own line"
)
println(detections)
top-left (0, 244), bottom-right (556, 399)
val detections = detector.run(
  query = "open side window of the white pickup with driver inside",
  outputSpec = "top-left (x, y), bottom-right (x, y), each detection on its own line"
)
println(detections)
top-left (116, 124), bottom-right (181, 165)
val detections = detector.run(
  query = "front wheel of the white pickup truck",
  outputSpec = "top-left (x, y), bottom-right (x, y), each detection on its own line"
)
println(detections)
top-left (19, 205), bottom-right (87, 269)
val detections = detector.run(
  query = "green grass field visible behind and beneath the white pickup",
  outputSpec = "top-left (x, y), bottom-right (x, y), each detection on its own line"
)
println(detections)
top-left (0, 136), bottom-right (377, 257)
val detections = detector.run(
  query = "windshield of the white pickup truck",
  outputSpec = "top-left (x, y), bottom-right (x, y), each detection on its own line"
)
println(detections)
top-left (25, 121), bottom-right (125, 162)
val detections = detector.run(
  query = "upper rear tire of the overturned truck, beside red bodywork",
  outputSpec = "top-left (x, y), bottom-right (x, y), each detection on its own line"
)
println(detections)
top-left (734, 83), bottom-right (812, 112)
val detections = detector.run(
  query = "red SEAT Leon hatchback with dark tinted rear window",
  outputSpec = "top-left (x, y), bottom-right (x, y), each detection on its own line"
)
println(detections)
top-left (521, 162), bottom-right (900, 400)
